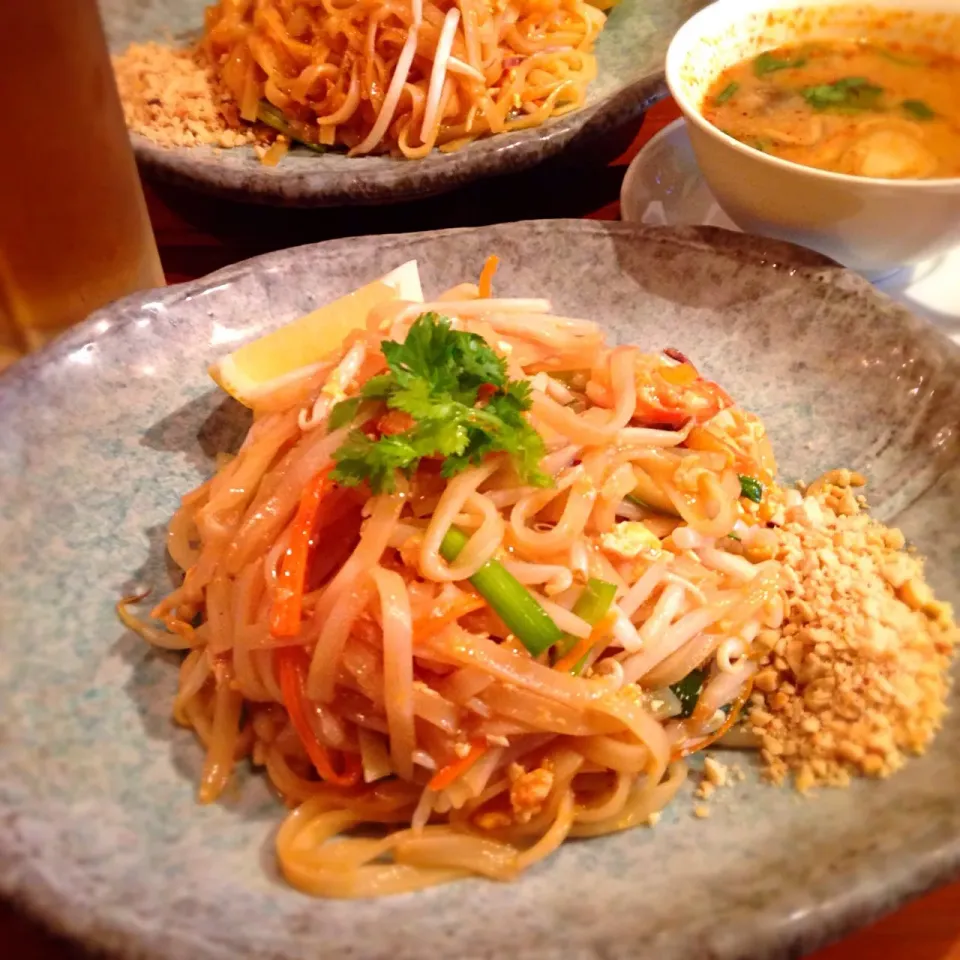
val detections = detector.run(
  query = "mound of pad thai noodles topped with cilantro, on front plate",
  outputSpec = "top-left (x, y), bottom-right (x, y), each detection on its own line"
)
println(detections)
top-left (127, 263), bottom-right (804, 897)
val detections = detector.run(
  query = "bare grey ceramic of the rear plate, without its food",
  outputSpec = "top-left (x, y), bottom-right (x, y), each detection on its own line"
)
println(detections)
top-left (99, 0), bottom-right (706, 207)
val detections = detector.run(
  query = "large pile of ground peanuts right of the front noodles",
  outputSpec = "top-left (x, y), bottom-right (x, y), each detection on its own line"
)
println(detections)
top-left (745, 470), bottom-right (958, 791)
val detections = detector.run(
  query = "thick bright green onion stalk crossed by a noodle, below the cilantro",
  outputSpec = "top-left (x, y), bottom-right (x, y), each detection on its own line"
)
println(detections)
top-left (440, 527), bottom-right (564, 657)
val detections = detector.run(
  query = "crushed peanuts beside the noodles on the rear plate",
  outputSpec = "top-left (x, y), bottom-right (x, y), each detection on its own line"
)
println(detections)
top-left (113, 43), bottom-right (274, 149)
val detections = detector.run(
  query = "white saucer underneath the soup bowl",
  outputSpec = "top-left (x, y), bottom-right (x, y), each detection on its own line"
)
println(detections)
top-left (620, 118), bottom-right (960, 343)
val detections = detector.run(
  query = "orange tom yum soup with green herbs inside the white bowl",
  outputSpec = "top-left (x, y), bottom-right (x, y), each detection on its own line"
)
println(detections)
top-left (702, 40), bottom-right (960, 179)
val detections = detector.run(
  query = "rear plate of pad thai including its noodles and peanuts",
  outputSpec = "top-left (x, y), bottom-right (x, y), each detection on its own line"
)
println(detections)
top-left (102, 0), bottom-right (702, 206)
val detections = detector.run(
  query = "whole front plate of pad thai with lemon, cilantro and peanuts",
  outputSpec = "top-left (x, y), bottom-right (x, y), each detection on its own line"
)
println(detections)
top-left (0, 222), bottom-right (960, 957)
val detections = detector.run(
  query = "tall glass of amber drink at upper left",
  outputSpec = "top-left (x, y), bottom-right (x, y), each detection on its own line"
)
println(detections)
top-left (0, 0), bottom-right (163, 369)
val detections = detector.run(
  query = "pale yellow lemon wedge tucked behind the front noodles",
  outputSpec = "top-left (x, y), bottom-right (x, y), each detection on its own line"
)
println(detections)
top-left (209, 260), bottom-right (423, 407)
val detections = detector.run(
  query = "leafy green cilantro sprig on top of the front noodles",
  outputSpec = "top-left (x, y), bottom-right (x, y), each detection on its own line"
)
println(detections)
top-left (330, 313), bottom-right (550, 493)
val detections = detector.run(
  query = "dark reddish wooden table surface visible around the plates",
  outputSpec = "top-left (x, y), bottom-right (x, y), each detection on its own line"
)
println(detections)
top-left (7, 100), bottom-right (960, 960)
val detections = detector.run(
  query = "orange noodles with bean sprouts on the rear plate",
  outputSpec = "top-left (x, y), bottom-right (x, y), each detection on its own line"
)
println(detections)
top-left (202, 0), bottom-right (605, 162)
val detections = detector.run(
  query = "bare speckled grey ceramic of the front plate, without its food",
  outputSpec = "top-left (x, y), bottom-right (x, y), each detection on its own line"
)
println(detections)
top-left (0, 221), bottom-right (960, 960)
